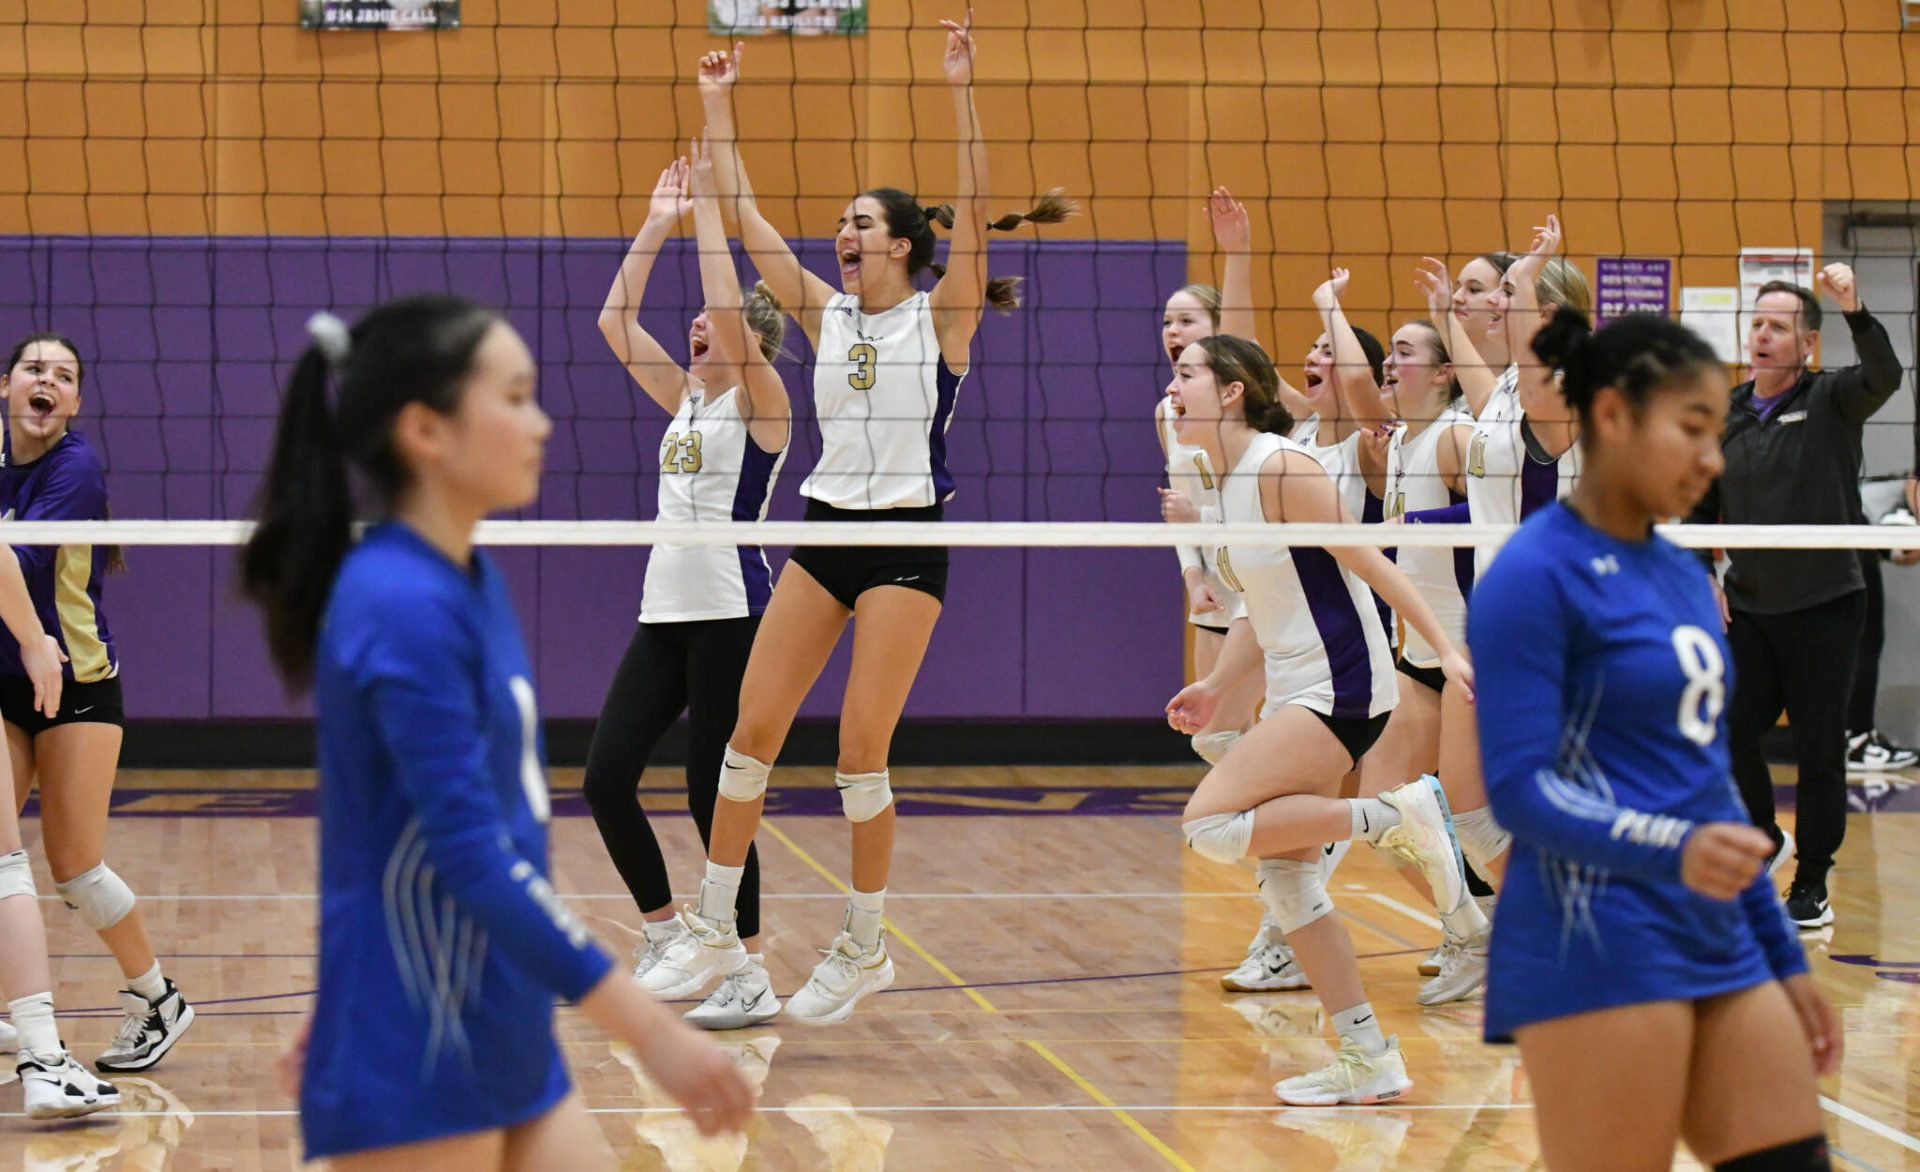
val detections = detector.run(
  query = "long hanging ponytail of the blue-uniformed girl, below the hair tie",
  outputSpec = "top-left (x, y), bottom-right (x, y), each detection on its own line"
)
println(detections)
top-left (240, 342), bottom-right (353, 692)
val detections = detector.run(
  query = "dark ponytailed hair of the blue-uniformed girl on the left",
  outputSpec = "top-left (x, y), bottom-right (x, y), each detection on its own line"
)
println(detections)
top-left (240, 294), bottom-right (499, 692)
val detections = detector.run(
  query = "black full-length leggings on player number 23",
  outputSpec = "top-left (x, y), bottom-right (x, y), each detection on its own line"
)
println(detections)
top-left (586, 617), bottom-right (760, 936)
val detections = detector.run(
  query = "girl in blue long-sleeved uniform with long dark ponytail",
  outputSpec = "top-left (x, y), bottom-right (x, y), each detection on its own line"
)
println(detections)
top-left (242, 296), bottom-right (751, 1172)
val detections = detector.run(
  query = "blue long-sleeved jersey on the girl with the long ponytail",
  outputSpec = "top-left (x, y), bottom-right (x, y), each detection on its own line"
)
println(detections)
top-left (300, 523), bottom-right (611, 1159)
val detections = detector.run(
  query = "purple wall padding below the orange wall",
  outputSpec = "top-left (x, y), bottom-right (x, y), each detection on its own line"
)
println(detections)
top-left (0, 236), bottom-right (1187, 720)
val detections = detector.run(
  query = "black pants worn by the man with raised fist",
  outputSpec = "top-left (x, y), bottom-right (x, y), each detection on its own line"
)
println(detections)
top-left (1726, 590), bottom-right (1866, 880)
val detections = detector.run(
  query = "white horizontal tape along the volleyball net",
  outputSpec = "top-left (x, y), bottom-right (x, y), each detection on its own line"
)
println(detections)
top-left (0, 521), bottom-right (1920, 549)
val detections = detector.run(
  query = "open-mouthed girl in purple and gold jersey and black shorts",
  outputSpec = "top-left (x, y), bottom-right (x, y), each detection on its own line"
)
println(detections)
top-left (0, 332), bottom-right (194, 1072)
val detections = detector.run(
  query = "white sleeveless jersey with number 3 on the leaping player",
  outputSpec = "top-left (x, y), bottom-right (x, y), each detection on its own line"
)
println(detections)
top-left (801, 292), bottom-right (964, 509)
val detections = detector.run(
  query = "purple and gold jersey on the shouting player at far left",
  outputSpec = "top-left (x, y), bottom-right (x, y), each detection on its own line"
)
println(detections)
top-left (0, 430), bottom-right (119, 684)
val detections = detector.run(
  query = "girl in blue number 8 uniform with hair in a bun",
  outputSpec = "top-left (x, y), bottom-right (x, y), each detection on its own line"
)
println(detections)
top-left (1467, 309), bottom-right (1839, 1172)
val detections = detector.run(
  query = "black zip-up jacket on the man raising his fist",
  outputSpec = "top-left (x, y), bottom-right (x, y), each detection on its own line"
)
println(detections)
top-left (1688, 307), bottom-right (1901, 615)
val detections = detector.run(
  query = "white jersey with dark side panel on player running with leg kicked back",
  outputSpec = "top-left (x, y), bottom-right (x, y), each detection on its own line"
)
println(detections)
top-left (1215, 434), bottom-right (1400, 719)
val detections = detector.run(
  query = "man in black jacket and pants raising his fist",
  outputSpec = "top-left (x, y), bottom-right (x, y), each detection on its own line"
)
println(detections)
top-left (1692, 265), bottom-right (1901, 928)
